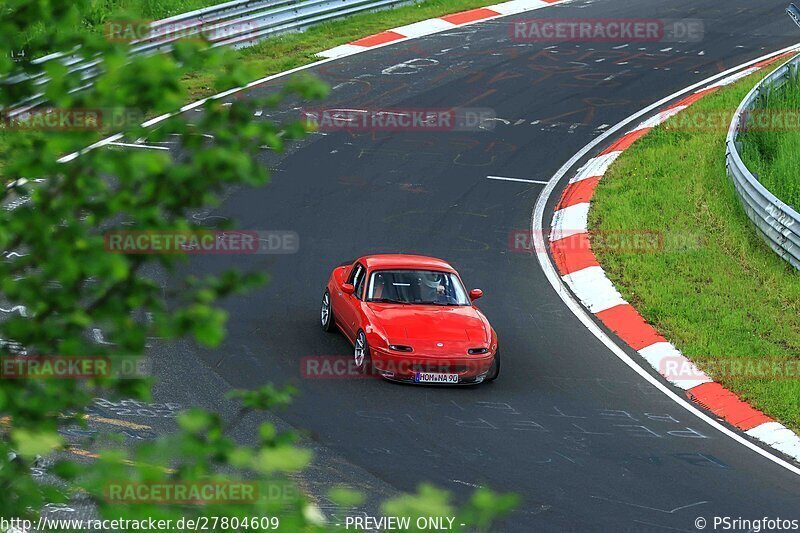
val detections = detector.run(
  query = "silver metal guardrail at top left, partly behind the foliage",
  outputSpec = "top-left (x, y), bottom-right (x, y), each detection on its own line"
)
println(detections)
top-left (0, 0), bottom-right (414, 117)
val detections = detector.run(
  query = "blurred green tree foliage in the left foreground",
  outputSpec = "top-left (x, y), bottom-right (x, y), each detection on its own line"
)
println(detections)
top-left (0, 0), bottom-right (514, 531)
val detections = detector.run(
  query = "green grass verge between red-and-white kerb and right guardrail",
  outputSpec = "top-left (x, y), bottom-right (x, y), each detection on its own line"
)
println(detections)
top-left (589, 67), bottom-right (800, 430)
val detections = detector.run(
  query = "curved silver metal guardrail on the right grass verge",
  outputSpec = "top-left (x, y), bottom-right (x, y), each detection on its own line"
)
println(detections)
top-left (725, 55), bottom-right (800, 270)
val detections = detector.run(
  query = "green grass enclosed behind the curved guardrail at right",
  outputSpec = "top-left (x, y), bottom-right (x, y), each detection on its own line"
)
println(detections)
top-left (740, 71), bottom-right (800, 211)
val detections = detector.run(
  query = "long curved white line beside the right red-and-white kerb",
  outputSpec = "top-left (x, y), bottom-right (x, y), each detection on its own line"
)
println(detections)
top-left (531, 43), bottom-right (800, 476)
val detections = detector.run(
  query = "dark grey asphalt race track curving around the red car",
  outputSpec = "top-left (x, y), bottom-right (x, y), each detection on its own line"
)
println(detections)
top-left (134, 0), bottom-right (800, 531)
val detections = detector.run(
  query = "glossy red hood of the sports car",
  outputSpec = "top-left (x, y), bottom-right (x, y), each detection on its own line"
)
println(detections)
top-left (369, 303), bottom-right (491, 344)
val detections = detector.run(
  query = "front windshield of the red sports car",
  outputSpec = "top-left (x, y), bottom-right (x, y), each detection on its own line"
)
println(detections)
top-left (367, 270), bottom-right (470, 305)
